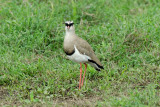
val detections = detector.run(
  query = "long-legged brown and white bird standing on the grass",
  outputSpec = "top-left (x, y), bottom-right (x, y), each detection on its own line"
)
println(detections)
top-left (63, 21), bottom-right (104, 89)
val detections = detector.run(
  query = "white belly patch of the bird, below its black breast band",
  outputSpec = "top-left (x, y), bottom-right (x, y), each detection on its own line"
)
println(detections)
top-left (68, 45), bottom-right (91, 63)
